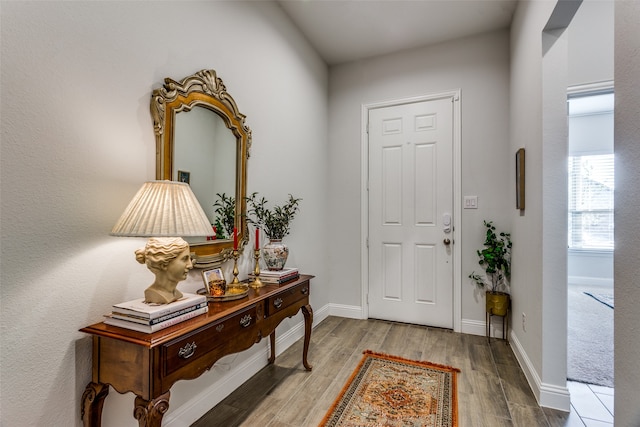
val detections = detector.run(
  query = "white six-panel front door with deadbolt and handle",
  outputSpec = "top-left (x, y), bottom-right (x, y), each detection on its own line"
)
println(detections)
top-left (368, 97), bottom-right (454, 328)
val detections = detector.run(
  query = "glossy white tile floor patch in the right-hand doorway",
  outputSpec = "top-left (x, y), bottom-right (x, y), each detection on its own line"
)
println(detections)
top-left (566, 381), bottom-right (614, 427)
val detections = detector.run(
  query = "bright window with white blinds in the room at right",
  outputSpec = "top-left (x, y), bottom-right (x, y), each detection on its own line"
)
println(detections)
top-left (569, 154), bottom-right (614, 250)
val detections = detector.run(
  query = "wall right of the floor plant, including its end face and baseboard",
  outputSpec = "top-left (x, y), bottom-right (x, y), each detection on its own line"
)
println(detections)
top-left (510, 1), bottom-right (569, 409)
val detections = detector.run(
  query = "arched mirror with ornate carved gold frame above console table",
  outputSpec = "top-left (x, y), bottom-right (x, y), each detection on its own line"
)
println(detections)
top-left (151, 70), bottom-right (251, 268)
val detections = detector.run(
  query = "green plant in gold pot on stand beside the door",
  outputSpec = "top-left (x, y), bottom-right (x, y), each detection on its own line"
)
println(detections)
top-left (469, 221), bottom-right (513, 316)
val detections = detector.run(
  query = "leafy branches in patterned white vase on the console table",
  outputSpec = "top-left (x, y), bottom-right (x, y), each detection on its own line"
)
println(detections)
top-left (246, 192), bottom-right (302, 270)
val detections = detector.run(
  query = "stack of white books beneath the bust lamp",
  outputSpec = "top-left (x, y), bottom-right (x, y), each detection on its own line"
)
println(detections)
top-left (104, 293), bottom-right (209, 334)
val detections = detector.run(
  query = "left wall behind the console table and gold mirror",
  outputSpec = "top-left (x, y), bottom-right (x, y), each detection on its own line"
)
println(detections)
top-left (0, 1), bottom-right (329, 427)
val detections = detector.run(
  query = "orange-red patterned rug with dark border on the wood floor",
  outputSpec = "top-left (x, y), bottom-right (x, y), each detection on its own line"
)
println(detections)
top-left (320, 350), bottom-right (460, 427)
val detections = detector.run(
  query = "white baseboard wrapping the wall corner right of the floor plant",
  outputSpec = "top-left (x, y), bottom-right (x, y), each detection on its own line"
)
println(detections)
top-left (509, 333), bottom-right (571, 412)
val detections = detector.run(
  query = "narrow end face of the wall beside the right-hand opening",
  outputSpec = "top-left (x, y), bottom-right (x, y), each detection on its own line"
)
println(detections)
top-left (540, 24), bottom-right (570, 410)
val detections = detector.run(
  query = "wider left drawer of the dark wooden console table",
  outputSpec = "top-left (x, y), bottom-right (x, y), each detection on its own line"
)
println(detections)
top-left (161, 305), bottom-right (262, 376)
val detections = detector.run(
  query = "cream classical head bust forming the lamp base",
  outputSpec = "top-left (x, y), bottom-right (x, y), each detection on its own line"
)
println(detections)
top-left (136, 237), bottom-right (193, 304)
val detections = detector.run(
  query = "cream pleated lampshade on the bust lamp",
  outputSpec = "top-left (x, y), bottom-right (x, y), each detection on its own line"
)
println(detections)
top-left (110, 181), bottom-right (213, 237)
